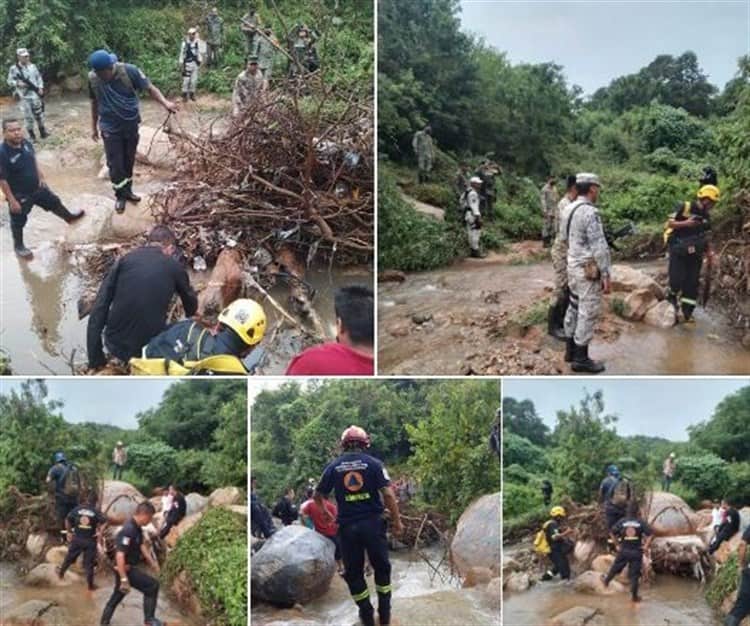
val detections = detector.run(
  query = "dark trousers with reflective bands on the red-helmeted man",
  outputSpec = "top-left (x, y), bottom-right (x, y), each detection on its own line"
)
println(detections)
top-left (339, 517), bottom-right (391, 626)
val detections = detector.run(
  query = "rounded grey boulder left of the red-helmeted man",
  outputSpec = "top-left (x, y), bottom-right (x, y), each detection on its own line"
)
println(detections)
top-left (251, 525), bottom-right (336, 607)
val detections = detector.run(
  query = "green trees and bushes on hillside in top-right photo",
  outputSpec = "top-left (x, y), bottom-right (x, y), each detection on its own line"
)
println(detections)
top-left (378, 0), bottom-right (750, 270)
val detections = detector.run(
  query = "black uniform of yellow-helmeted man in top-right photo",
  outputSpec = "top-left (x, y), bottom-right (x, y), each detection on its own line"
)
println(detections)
top-left (668, 201), bottom-right (711, 319)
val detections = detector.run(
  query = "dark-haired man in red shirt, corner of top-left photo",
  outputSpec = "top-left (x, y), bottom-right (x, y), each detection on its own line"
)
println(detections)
top-left (286, 285), bottom-right (375, 376)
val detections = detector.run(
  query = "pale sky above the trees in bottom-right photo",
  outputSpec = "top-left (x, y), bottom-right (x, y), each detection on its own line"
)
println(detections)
top-left (503, 378), bottom-right (750, 441)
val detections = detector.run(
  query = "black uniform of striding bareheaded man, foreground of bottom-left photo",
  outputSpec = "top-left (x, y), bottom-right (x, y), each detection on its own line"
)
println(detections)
top-left (101, 518), bottom-right (159, 626)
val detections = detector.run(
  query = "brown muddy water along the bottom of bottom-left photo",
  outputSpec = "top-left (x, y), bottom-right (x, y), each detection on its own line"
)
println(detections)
top-left (0, 563), bottom-right (204, 626)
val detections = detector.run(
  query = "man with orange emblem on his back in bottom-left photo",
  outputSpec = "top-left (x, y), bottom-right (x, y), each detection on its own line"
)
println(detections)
top-left (57, 491), bottom-right (107, 591)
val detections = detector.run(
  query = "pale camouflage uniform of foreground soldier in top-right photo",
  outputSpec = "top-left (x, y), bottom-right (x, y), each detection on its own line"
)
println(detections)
top-left (560, 198), bottom-right (612, 346)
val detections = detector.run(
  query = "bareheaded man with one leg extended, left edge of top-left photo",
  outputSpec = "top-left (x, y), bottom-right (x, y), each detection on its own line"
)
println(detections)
top-left (0, 118), bottom-right (84, 261)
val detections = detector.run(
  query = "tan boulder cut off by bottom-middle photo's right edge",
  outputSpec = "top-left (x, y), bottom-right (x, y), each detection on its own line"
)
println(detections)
top-left (451, 493), bottom-right (502, 575)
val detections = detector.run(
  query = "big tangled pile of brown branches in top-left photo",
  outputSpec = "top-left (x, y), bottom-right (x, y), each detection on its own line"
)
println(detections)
top-left (156, 74), bottom-right (374, 266)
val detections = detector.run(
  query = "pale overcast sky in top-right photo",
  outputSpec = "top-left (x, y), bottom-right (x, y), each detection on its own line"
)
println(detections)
top-left (461, 0), bottom-right (750, 95)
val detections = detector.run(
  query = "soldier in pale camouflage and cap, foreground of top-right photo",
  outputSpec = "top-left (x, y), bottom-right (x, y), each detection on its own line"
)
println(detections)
top-left (560, 173), bottom-right (612, 374)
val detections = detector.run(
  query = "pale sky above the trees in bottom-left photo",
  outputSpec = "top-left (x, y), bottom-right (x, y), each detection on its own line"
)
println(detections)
top-left (0, 377), bottom-right (173, 428)
